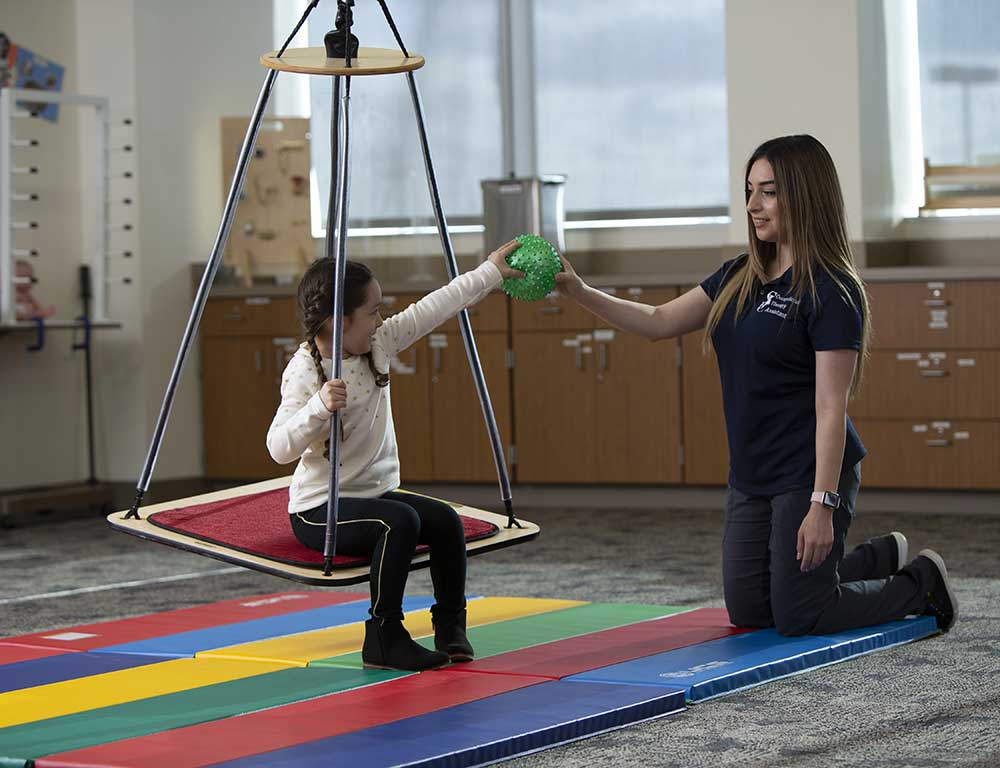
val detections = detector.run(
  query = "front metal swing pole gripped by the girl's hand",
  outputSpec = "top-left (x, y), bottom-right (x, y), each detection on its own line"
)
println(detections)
top-left (323, 76), bottom-right (351, 576)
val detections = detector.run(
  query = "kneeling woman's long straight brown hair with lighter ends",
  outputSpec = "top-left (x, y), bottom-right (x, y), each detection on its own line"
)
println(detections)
top-left (703, 134), bottom-right (871, 397)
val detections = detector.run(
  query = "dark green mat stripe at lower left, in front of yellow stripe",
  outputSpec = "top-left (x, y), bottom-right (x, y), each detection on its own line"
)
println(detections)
top-left (0, 667), bottom-right (402, 768)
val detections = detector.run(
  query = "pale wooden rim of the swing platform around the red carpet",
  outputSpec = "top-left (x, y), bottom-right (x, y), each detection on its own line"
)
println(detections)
top-left (107, 477), bottom-right (540, 587)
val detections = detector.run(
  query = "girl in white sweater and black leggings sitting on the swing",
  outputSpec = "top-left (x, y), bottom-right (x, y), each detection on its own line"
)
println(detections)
top-left (267, 240), bottom-right (524, 671)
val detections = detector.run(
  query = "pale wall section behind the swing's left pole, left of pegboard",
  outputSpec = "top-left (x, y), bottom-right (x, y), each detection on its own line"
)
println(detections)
top-left (133, 0), bottom-right (280, 479)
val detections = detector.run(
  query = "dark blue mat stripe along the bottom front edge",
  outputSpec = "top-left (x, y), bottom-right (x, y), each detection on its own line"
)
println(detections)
top-left (206, 681), bottom-right (684, 768)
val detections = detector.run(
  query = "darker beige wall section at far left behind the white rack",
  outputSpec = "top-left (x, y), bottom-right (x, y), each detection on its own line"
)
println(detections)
top-left (0, 0), bottom-right (87, 489)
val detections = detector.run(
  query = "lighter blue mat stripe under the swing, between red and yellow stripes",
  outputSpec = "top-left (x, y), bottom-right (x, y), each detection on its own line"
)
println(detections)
top-left (94, 597), bottom-right (434, 658)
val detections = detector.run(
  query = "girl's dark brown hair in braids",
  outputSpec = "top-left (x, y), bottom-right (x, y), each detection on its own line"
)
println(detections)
top-left (298, 256), bottom-right (389, 458)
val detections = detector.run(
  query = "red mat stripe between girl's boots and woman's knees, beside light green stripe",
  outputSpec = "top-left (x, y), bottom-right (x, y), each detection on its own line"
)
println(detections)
top-left (454, 608), bottom-right (750, 680)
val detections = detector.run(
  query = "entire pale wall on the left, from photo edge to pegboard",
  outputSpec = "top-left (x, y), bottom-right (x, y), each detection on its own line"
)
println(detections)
top-left (0, 0), bottom-right (280, 489)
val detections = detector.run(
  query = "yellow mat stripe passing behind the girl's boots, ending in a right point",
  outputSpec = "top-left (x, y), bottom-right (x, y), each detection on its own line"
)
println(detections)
top-left (196, 597), bottom-right (585, 667)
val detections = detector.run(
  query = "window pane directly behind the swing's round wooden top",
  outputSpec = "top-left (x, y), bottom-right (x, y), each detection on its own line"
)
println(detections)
top-left (309, 0), bottom-right (503, 232)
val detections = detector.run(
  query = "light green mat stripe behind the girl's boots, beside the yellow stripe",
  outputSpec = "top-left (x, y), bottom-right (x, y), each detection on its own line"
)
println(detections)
top-left (309, 603), bottom-right (689, 669)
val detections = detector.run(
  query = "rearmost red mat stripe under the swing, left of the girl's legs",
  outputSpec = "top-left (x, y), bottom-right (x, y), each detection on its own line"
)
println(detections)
top-left (2, 591), bottom-right (368, 651)
